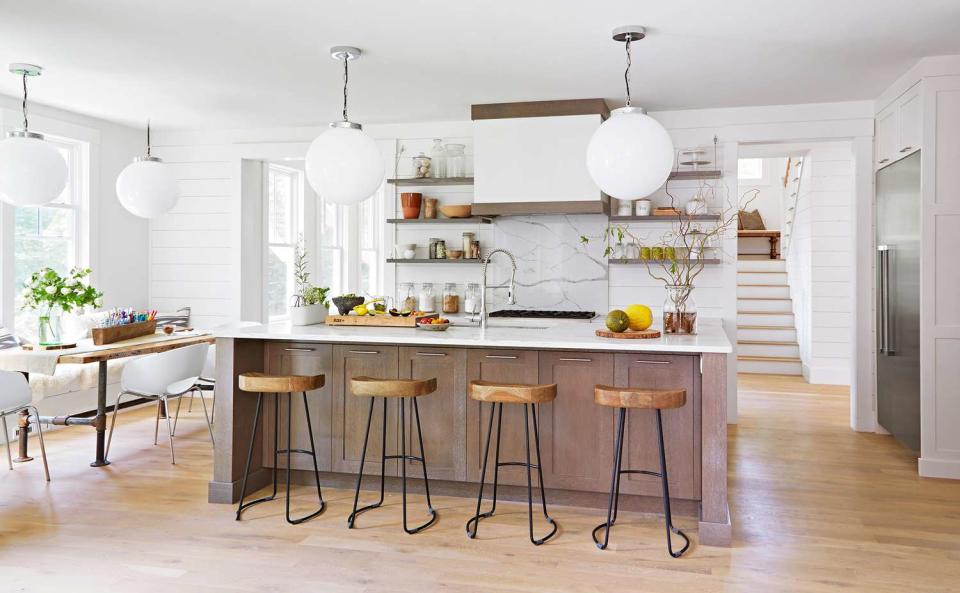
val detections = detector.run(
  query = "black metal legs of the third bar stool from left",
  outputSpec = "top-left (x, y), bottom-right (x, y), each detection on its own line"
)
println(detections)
top-left (466, 402), bottom-right (557, 546)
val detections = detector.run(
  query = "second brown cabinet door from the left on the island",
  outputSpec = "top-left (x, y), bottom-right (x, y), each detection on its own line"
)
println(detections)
top-left (333, 344), bottom-right (399, 476)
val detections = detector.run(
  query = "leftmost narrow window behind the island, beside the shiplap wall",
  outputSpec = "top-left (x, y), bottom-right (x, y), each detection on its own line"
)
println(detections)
top-left (265, 163), bottom-right (303, 321)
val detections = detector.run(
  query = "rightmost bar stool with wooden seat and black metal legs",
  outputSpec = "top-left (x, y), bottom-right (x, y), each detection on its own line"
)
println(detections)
top-left (592, 385), bottom-right (690, 558)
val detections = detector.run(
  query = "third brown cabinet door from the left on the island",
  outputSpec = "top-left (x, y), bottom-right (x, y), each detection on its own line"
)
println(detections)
top-left (400, 346), bottom-right (467, 481)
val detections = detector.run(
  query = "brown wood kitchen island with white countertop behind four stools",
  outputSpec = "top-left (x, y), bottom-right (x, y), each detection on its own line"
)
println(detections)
top-left (208, 321), bottom-right (732, 545)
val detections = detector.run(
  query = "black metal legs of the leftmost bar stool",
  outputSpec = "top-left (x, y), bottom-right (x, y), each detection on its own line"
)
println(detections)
top-left (236, 391), bottom-right (326, 525)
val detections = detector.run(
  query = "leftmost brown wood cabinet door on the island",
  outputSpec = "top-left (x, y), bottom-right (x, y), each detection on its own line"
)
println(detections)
top-left (262, 342), bottom-right (333, 471)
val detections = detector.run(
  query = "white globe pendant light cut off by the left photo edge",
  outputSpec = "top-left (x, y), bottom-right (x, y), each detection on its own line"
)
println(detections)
top-left (0, 64), bottom-right (67, 206)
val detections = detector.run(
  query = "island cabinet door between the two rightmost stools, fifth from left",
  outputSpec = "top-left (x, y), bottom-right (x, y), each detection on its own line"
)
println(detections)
top-left (540, 352), bottom-right (614, 492)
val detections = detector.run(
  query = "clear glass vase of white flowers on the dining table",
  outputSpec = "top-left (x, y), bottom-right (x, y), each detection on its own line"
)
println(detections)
top-left (20, 268), bottom-right (103, 346)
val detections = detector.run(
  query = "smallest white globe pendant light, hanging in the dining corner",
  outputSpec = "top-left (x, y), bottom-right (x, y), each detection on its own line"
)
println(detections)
top-left (117, 121), bottom-right (177, 218)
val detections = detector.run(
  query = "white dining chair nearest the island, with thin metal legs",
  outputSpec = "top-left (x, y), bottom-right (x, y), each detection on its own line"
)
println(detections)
top-left (104, 344), bottom-right (213, 464)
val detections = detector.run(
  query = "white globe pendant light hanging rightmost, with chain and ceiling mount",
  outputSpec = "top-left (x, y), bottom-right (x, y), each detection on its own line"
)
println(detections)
top-left (587, 25), bottom-right (674, 200)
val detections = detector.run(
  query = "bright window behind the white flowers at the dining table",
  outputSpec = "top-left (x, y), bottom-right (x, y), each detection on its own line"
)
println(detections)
top-left (13, 135), bottom-right (88, 341)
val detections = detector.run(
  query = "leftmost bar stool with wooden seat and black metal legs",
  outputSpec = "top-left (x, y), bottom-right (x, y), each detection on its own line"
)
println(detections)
top-left (237, 373), bottom-right (326, 525)
